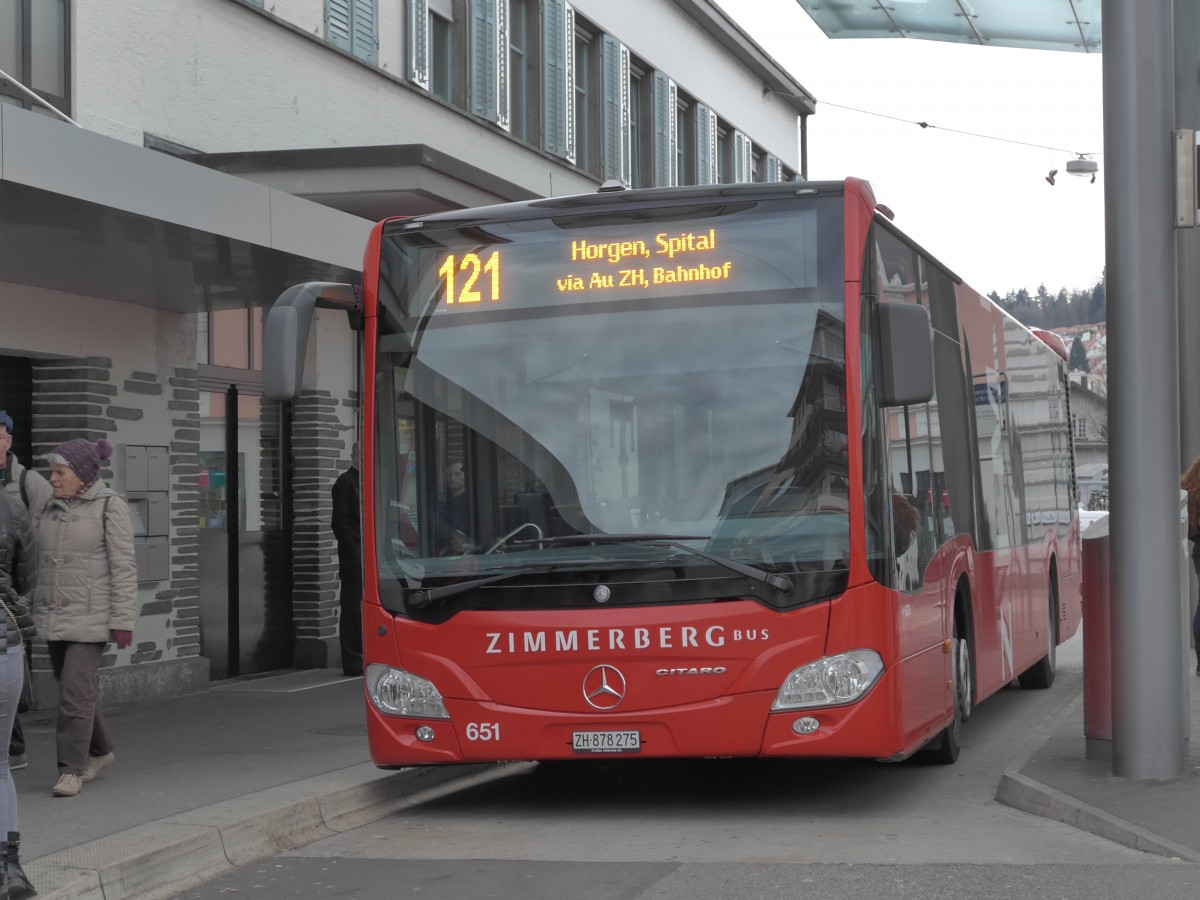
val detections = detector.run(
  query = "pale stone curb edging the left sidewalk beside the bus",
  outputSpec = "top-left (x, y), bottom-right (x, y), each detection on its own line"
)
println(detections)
top-left (25, 763), bottom-right (533, 900)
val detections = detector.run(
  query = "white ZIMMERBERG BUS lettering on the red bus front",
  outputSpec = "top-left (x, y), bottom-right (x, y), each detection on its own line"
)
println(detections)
top-left (485, 625), bottom-right (770, 655)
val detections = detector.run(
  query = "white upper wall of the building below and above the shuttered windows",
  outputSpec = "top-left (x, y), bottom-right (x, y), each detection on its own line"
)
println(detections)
top-left (72, 0), bottom-right (799, 194)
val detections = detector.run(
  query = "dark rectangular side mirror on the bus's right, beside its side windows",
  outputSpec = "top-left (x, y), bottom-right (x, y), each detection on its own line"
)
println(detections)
top-left (875, 300), bottom-right (934, 407)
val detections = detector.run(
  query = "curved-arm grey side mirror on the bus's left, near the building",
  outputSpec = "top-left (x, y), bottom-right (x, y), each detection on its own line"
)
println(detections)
top-left (263, 281), bottom-right (360, 400)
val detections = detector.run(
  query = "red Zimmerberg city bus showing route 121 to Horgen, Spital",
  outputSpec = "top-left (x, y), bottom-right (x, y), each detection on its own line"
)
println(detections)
top-left (266, 179), bottom-right (1080, 768)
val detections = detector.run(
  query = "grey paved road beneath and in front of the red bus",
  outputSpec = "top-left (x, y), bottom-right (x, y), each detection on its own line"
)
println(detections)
top-left (169, 638), bottom-right (1200, 900)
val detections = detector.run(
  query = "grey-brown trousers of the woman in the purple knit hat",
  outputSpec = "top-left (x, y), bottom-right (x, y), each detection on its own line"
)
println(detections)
top-left (46, 641), bottom-right (113, 775)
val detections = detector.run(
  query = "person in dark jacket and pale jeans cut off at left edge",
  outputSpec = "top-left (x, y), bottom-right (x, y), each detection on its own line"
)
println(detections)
top-left (0, 492), bottom-right (37, 900)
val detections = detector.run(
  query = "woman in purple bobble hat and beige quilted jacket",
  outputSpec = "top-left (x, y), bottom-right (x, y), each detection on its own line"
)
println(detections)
top-left (34, 438), bottom-right (138, 797)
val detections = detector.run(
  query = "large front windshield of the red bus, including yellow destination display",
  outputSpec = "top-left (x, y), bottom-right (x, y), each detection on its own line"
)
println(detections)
top-left (374, 191), bottom-right (850, 619)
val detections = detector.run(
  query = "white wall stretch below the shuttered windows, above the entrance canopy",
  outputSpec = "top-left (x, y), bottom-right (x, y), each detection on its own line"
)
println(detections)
top-left (72, 0), bottom-right (595, 194)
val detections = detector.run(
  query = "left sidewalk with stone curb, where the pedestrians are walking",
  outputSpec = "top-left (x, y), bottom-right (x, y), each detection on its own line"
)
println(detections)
top-left (13, 670), bottom-right (530, 900)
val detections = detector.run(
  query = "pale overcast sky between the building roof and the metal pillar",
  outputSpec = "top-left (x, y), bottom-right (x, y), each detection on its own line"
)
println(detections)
top-left (716, 0), bottom-right (1104, 301)
